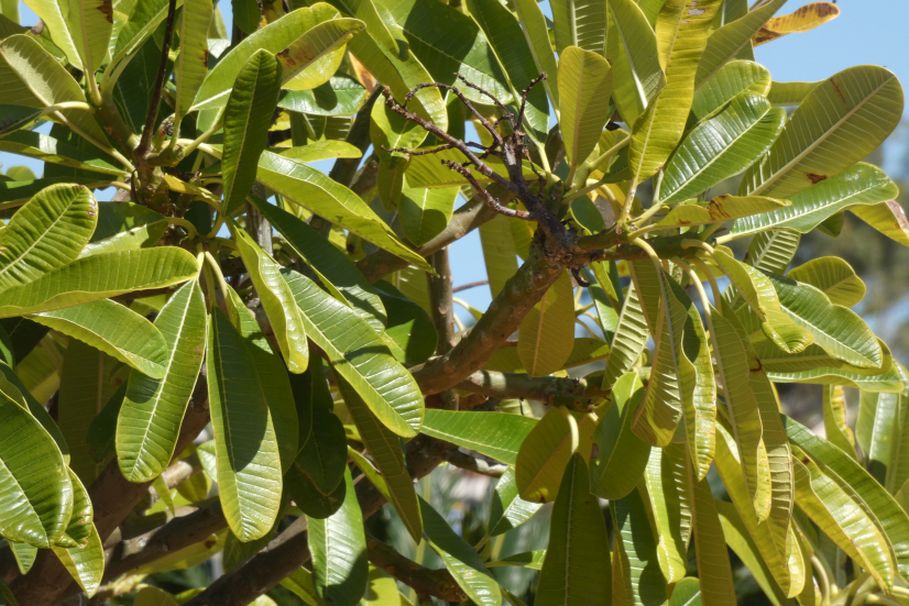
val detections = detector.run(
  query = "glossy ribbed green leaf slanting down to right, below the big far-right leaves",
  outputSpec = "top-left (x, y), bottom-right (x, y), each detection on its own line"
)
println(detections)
top-left (769, 275), bottom-right (884, 368)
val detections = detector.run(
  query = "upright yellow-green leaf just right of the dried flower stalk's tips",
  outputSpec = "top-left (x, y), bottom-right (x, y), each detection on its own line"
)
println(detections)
top-left (558, 46), bottom-right (612, 168)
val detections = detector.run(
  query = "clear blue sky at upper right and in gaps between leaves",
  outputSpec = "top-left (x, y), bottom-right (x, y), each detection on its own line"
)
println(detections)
top-left (0, 0), bottom-right (909, 309)
